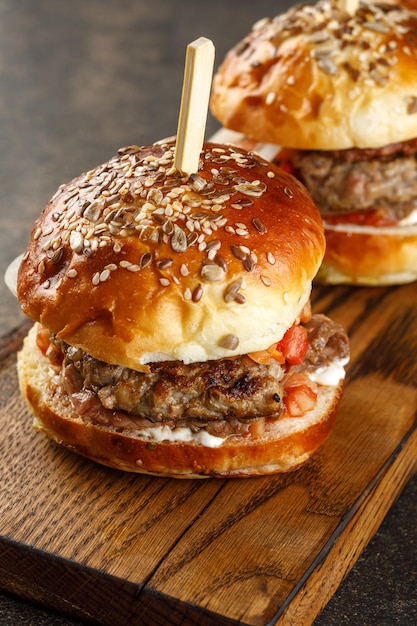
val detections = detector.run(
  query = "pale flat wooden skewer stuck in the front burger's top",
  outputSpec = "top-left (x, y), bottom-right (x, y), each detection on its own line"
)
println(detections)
top-left (174, 37), bottom-right (214, 174)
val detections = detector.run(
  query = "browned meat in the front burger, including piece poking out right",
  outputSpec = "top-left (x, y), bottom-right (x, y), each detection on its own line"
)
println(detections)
top-left (52, 315), bottom-right (349, 426)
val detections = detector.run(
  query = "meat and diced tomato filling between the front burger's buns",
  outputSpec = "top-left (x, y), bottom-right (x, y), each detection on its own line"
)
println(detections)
top-left (38, 315), bottom-right (349, 438)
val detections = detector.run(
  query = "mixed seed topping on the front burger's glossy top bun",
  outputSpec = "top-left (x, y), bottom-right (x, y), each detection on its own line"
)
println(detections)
top-left (33, 142), bottom-right (272, 302)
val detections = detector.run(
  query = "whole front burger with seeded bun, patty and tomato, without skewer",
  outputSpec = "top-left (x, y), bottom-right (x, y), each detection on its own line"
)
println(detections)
top-left (17, 140), bottom-right (349, 478)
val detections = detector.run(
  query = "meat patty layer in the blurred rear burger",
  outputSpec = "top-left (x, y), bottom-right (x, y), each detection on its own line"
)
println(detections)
top-left (294, 140), bottom-right (417, 224)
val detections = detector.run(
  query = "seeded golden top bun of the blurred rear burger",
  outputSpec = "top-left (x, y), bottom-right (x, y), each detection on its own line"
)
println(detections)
top-left (211, 0), bottom-right (417, 150)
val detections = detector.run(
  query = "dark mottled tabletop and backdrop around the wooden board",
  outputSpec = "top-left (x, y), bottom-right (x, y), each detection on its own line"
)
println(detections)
top-left (0, 0), bottom-right (417, 626)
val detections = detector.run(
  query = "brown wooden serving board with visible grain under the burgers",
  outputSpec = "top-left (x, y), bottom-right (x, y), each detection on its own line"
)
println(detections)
top-left (0, 283), bottom-right (417, 626)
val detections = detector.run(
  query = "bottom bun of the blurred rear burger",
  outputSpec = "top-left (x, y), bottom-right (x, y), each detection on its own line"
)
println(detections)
top-left (315, 223), bottom-right (417, 286)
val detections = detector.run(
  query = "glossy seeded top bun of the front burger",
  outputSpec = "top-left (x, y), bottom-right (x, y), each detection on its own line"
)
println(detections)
top-left (17, 141), bottom-right (325, 370)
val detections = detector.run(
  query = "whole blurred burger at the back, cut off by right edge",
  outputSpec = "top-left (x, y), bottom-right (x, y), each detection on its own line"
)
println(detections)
top-left (211, 0), bottom-right (417, 285)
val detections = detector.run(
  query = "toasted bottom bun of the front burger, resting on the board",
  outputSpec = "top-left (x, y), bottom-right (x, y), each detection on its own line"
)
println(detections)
top-left (17, 324), bottom-right (343, 478)
